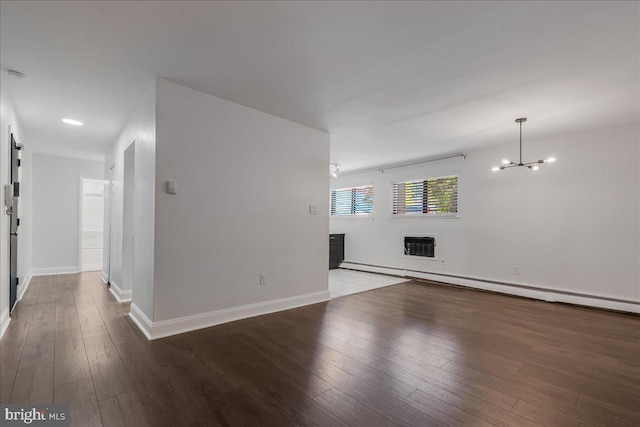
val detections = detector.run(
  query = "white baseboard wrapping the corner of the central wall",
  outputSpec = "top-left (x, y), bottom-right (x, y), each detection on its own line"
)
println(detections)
top-left (130, 290), bottom-right (330, 340)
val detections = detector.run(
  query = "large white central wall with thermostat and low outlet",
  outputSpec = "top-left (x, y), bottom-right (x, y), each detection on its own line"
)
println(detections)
top-left (154, 80), bottom-right (329, 327)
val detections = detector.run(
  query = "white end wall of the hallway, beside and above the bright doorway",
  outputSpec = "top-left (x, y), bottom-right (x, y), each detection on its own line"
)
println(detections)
top-left (33, 153), bottom-right (104, 274)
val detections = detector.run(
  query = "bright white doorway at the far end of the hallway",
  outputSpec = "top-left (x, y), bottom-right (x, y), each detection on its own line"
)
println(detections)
top-left (80, 178), bottom-right (104, 271)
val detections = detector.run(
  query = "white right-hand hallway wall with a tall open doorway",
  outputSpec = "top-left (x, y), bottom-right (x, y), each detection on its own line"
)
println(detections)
top-left (103, 82), bottom-right (156, 319)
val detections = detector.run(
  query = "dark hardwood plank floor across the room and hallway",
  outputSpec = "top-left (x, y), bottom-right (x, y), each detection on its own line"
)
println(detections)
top-left (0, 273), bottom-right (640, 427)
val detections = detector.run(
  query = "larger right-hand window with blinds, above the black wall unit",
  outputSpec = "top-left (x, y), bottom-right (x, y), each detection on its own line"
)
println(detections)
top-left (393, 176), bottom-right (458, 216)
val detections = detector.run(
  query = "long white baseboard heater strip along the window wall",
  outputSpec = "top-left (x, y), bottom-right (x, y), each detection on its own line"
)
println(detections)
top-left (340, 262), bottom-right (640, 314)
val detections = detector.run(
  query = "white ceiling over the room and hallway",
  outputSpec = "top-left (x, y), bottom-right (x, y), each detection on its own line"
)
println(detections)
top-left (0, 1), bottom-right (640, 170)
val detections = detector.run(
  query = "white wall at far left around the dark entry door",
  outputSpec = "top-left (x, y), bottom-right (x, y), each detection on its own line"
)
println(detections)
top-left (0, 73), bottom-right (33, 337)
